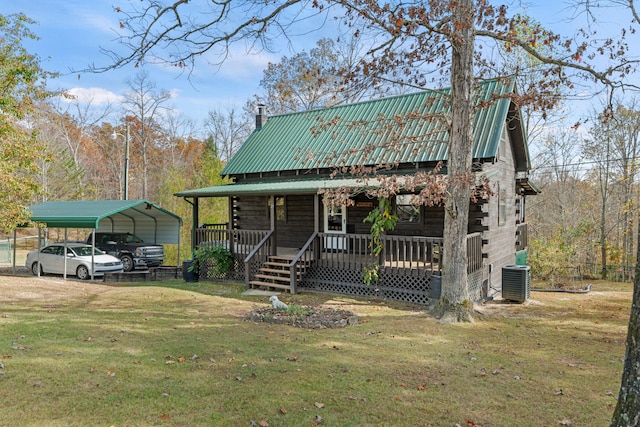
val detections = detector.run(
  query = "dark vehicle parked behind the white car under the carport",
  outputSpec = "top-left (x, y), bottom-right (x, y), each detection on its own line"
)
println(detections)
top-left (87, 233), bottom-right (164, 271)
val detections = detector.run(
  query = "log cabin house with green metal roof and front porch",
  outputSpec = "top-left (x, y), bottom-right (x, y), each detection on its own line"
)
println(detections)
top-left (175, 80), bottom-right (538, 304)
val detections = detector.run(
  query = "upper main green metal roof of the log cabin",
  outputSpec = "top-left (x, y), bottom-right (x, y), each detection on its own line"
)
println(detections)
top-left (221, 80), bottom-right (528, 175)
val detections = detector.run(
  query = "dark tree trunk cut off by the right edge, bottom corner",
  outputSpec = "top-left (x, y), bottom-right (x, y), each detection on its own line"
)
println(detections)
top-left (611, 227), bottom-right (640, 427)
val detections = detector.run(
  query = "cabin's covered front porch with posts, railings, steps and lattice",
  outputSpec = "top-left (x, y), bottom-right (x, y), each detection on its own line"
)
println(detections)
top-left (176, 180), bottom-right (483, 304)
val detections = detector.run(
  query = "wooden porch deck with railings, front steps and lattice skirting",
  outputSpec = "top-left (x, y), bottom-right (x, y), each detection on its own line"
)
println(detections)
top-left (196, 226), bottom-right (483, 304)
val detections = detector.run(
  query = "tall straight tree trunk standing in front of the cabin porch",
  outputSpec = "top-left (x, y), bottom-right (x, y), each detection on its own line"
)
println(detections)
top-left (438, 0), bottom-right (475, 323)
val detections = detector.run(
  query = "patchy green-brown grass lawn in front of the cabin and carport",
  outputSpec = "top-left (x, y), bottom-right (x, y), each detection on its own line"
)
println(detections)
top-left (0, 276), bottom-right (632, 427)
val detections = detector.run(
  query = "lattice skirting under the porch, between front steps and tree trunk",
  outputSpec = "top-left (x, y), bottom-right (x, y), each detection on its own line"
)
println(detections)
top-left (298, 266), bottom-right (434, 304)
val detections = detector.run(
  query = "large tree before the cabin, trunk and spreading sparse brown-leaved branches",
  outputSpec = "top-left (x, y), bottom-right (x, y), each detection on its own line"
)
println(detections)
top-left (109, 0), bottom-right (632, 320)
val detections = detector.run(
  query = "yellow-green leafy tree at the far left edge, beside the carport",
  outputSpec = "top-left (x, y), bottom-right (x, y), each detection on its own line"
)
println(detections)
top-left (0, 14), bottom-right (55, 231)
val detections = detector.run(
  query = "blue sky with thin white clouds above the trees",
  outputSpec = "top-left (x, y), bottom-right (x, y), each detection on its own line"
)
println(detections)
top-left (1, 0), bottom-right (640, 131)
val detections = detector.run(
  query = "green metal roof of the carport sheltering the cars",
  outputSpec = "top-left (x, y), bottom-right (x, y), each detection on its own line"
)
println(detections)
top-left (29, 200), bottom-right (182, 228)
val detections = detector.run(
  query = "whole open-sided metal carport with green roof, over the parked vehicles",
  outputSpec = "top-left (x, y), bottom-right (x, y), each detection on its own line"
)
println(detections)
top-left (14, 200), bottom-right (182, 279)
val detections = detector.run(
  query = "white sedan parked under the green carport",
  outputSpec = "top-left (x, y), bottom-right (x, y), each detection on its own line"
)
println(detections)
top-left (25, 243), bottom-right (123, 280)
